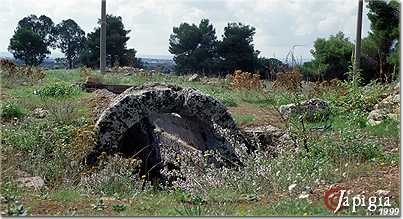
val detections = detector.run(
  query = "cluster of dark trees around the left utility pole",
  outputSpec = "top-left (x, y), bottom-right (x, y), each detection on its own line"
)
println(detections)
top-left (8, 15), bottom-right (141, 69)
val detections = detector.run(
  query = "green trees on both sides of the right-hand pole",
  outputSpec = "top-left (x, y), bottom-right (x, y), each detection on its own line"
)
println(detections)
top-left (301, 0), bottom-right (400, 82)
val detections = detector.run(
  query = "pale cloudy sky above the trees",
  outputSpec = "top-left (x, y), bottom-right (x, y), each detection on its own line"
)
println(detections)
top-left (0, 0), bottom-right (370, 60)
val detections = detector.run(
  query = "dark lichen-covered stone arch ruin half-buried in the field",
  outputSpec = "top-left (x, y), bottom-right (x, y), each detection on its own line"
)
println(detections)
top-left (87, 84), bottom-right (247, 179)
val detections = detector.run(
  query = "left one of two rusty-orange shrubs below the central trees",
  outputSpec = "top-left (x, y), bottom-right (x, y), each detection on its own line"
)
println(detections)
top-left (227, 70), bottom-right (262, 89)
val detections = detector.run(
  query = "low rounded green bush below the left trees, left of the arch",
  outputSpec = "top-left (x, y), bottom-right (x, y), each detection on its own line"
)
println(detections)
top-left (35, 82), bottom-right (80, 97)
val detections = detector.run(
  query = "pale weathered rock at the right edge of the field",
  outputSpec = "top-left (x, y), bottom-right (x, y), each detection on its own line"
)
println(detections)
top-left (368, 85), bottom-right (400, 126)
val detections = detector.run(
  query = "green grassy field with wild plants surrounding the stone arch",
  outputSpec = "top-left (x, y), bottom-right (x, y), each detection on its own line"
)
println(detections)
top-left (1, 70), bottom-right (400, 216)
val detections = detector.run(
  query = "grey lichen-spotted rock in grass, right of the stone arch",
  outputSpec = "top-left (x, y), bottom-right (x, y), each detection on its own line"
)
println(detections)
top-left (279, 99), bottom-right (330, 121)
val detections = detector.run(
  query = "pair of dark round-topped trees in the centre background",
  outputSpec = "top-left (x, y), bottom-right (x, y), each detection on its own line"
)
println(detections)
top-left (169, 19), bottom-right (284, 78)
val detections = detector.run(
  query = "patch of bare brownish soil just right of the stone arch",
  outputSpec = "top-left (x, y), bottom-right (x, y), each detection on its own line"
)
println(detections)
top-left (228, 103), bottom-right (284, 128)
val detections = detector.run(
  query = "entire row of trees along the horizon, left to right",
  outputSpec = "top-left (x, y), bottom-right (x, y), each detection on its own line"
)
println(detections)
top-left (9, 0), bottom-right (400, 82)
